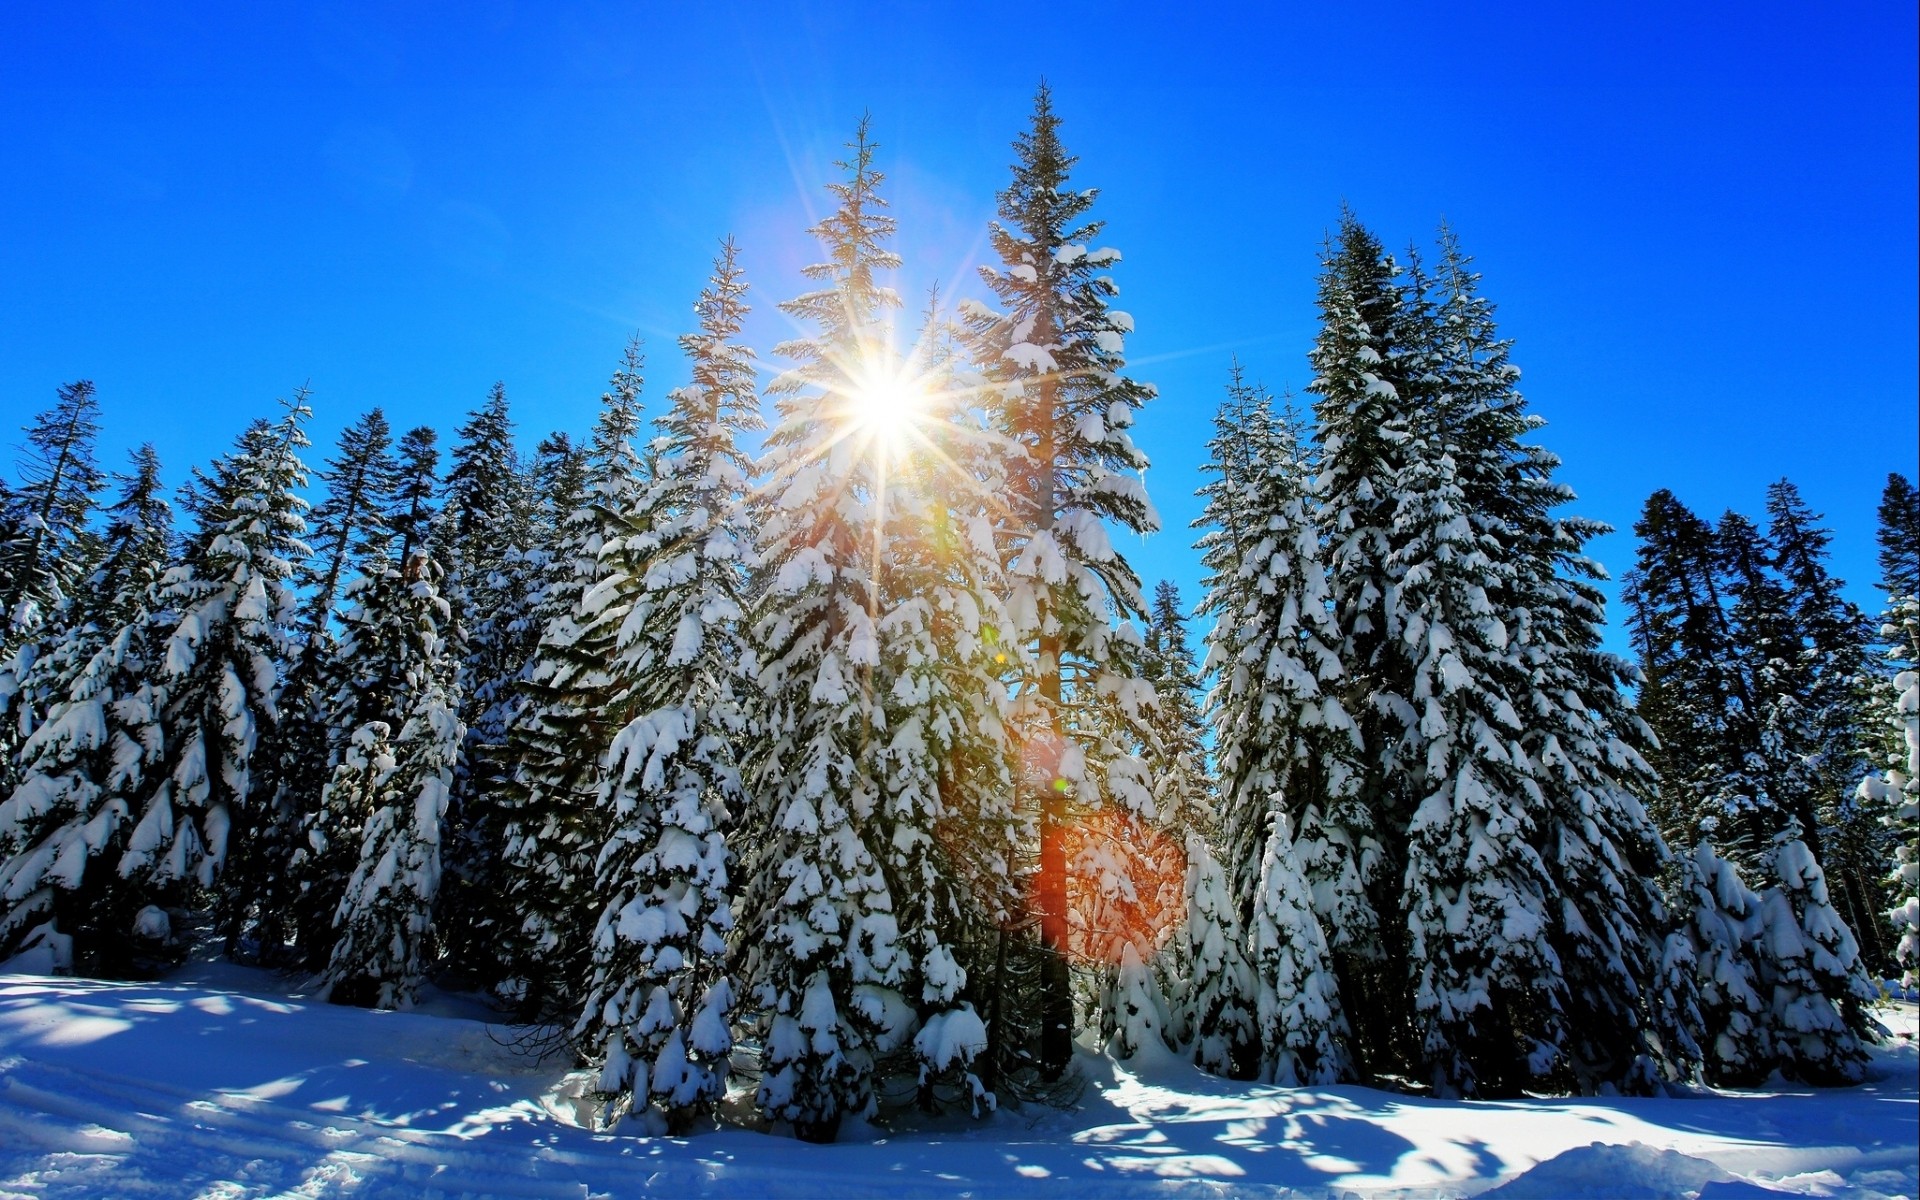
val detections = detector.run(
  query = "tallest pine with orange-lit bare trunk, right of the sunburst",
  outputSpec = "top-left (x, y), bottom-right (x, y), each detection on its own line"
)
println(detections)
top-left (964, 84), bottom-right (1160, 1077)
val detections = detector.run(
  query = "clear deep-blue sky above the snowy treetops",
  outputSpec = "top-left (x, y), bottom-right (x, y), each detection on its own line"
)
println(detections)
top-left (0, 0), bottom-right (1920, 645)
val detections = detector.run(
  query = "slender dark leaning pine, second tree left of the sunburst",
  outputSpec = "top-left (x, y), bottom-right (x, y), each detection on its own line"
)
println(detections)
top-left (493, 340), bottom-right (645, 1021)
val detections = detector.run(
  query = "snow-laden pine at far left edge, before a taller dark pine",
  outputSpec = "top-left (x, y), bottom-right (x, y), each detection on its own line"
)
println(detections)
top-left (0, 445), bottom-right (173, 975)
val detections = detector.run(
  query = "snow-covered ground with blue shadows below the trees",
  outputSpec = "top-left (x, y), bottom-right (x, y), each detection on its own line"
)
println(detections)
top-left (0, 966), bottom-right (1920, 1200)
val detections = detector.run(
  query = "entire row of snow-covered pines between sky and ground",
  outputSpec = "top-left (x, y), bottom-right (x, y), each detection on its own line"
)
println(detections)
top-left (0, 86), bottom-right (1920, 1140)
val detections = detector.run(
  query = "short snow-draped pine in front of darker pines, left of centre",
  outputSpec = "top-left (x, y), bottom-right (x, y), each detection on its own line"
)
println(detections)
top-left (321, 553), bottom-right (465, 1008)
